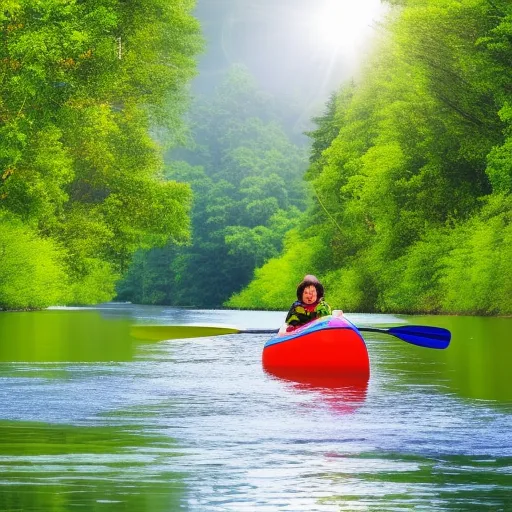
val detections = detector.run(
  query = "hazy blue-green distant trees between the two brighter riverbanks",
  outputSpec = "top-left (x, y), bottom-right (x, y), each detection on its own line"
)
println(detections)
top-left (118, 66), bottom-right (308, 307)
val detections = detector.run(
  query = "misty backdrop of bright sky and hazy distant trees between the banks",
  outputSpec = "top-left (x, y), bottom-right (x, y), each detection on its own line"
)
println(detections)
top-left (117, 0), bottom-right (390, 307)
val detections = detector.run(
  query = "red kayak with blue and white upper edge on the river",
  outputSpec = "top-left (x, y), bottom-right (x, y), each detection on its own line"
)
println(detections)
top-left (262, 316), bottom-right (370, 379)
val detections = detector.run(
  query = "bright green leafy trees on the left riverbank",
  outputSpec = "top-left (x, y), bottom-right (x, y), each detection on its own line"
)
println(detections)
top-left (0, 0), bottom-right (203, 309)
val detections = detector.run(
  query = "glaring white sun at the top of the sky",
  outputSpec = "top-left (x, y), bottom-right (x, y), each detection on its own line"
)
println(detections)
top-left (311, 0), bottom-right (383, 53)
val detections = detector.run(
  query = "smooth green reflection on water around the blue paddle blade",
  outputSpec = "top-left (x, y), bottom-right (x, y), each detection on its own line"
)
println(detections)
top-left (374, 316), bottom-right (512, 402)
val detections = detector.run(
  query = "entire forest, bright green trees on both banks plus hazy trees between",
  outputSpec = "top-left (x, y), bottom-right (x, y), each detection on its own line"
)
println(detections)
top-left (0, 0), bottom-right (512, 315)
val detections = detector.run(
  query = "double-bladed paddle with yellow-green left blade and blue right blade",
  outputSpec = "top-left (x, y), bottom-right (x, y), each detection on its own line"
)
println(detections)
top-left (131, 324), bottom-right (451, 349)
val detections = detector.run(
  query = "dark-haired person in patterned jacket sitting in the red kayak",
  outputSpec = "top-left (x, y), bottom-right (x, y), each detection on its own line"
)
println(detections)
top-left (282, 274), bottom-right (332, 333)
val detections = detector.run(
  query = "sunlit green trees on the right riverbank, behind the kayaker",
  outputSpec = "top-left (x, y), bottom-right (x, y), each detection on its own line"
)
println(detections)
top-left (227, 0), bottom-right (512, 314)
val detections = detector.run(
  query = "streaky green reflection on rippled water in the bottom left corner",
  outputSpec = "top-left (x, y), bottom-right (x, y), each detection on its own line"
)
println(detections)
top-left (0, 422), bottom-right (184, 512)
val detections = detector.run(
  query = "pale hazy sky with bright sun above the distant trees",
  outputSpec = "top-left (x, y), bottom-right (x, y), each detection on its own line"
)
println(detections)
top-left (196, 0), bottom-right (384, 107)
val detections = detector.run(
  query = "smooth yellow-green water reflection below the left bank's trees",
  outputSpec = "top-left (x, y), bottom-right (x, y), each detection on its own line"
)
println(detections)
top-left (0, 310), bottom-right (134, 362)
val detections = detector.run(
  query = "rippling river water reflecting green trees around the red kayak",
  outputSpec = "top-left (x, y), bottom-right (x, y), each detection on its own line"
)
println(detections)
top-left (0, 304), bottom-right (512, 512)
